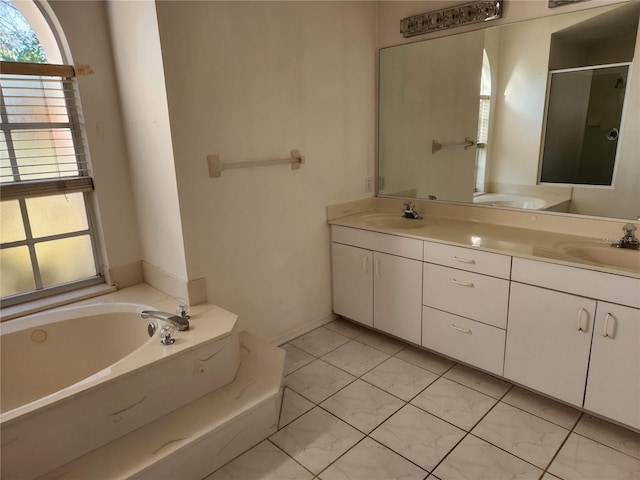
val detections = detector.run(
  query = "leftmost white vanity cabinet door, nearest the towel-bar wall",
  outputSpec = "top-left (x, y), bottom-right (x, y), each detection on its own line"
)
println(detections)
top-left (331, 243), bottom-right (373, 327)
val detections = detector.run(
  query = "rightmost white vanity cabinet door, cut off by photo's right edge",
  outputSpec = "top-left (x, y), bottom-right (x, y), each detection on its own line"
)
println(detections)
top-left (584, 302), bottom-right (640, 428)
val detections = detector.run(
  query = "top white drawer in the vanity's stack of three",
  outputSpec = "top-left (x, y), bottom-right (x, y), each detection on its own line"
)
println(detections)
top-left (423, 242), bottom-right (511, 279)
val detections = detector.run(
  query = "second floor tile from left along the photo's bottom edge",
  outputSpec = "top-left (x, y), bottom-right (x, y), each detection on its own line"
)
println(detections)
top-left (320, 438), bottom-right (427, 480)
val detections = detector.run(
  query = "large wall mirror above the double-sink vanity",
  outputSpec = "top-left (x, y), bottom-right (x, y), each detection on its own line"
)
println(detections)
top-left (377, 2), bottom-right (640, 220)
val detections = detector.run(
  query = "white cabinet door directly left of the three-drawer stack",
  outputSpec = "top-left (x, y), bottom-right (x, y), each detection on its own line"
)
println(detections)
top-left (373, 252), bottom-right (422, 345)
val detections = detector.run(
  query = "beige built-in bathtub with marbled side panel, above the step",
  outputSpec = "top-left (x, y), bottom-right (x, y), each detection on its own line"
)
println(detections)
top-left (0, 303), bottom-right (240, 480)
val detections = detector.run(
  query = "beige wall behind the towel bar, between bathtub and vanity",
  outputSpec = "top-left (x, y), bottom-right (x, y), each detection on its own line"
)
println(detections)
top-left (157, 2), bottom-right (376, 338)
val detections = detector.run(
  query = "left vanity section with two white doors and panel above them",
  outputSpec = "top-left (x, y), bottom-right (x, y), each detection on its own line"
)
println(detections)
top-left (331, 225), bottom-right (423, 344)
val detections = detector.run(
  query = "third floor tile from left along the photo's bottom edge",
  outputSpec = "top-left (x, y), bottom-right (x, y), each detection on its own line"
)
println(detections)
top-left (433, 435), bottom-right (542, 480)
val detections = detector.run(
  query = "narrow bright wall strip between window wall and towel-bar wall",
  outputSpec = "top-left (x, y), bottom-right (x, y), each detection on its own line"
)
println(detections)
top-left (108, 1), bottom-right (188, 284)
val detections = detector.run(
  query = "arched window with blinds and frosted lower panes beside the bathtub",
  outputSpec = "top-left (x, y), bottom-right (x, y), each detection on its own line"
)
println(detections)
top-left (0, 0), bottom-right (103, 306)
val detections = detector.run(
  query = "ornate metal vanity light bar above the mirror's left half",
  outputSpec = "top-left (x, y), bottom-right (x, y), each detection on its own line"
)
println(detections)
top-left (400, 0), bottom-right (504, 38)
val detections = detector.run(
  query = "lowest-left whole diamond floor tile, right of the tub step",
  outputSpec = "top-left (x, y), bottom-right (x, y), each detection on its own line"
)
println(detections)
top-left (270, 407), bottom-right (364, 474)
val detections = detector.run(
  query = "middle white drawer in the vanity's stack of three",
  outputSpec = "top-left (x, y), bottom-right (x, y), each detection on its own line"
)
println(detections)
top-left (422, 263), bottom-right (509, 328)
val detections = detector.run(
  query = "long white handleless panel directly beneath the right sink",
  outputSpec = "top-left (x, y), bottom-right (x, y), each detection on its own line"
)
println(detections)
top-left (511, 258), bottom-right (640, 308)
